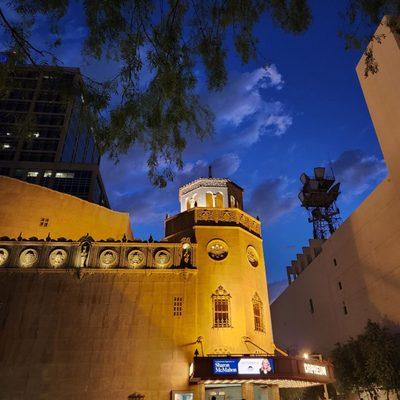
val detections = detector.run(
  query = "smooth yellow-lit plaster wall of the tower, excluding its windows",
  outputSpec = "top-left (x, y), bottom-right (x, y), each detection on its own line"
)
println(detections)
top-left (194, 226), bottom-right (274, 354)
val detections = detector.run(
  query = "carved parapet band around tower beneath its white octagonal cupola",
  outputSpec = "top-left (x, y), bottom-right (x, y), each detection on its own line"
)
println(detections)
top-left (165, 207), bottom-right (261, 237)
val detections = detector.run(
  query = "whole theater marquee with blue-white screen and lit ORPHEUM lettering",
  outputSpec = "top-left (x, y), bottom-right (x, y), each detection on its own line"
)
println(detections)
top-left (190, 356), bottom-right (335, 387)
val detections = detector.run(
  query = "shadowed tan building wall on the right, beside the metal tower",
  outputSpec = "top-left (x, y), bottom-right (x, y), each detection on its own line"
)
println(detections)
top-left (271, 18), bottom-right (400, 354)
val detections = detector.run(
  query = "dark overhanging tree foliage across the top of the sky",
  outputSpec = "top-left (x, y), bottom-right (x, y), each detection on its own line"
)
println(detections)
top-left (0, 0), bottom-right (400, 186)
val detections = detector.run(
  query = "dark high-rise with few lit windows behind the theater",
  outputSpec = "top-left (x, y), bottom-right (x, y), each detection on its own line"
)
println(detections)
top-left (0, 66), bottom-right (109, 207)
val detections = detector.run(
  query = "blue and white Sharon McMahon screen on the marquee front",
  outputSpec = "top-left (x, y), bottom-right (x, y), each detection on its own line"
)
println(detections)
top-left (213, 357), bottom-right (275, 377)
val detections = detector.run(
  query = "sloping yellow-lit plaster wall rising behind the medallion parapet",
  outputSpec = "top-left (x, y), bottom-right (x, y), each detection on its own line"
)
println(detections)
top-left (0, 176), bottom-right (132, 240)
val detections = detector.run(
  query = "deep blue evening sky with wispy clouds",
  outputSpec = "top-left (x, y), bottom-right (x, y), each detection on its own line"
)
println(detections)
top-left (1, 0), bottom-right (386, 297)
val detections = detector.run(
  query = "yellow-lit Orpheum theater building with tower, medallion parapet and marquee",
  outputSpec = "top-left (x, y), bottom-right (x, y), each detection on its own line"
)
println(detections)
top-left (0, 177), bottom-right (333, 400)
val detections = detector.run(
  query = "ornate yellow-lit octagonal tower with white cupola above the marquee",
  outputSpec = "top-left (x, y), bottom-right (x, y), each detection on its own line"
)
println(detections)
top-left (165, 178), bottom-right (275, 355)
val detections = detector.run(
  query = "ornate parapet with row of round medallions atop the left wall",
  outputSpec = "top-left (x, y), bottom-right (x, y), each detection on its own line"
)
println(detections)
top-left (0, 236), bottom-right (196, 270)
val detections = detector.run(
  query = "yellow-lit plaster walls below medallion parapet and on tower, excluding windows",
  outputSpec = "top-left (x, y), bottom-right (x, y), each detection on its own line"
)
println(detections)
top-left (0, 214), bottom-right (274, 400)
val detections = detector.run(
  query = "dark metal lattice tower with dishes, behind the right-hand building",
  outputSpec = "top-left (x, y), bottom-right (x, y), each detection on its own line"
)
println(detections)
top-left (299, 167), bottom-right (341, 239)
